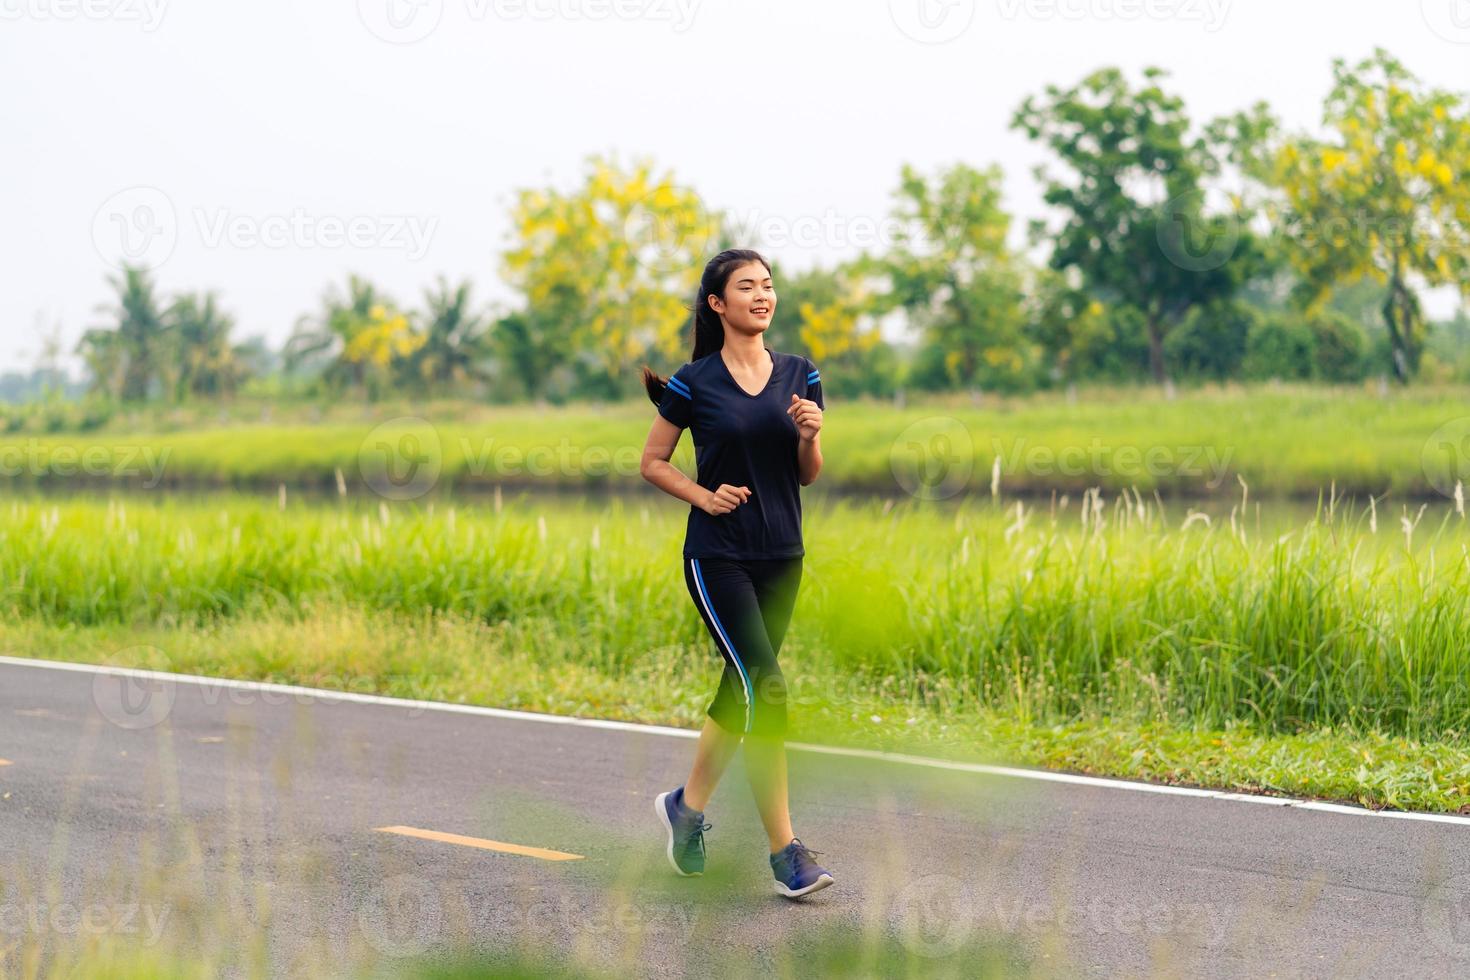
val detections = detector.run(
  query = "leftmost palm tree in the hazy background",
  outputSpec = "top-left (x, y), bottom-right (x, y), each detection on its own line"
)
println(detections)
top-left (76, 266), bottom-right (168, 401)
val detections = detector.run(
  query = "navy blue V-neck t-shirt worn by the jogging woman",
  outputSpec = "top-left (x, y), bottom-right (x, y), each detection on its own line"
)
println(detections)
top-left (659, 347), bottom-right (826, 560)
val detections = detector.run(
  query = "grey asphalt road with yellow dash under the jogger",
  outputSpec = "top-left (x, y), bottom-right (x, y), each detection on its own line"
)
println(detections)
top-left (0, 663), bottom-right (1470, 977)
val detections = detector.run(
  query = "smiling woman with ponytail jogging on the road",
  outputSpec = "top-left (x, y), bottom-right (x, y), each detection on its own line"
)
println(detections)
top-left (642, 248), bottom-right (832, 898)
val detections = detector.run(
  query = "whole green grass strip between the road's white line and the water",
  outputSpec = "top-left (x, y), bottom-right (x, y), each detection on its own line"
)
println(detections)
top-left (0, 494), bottom-right (1470, 811)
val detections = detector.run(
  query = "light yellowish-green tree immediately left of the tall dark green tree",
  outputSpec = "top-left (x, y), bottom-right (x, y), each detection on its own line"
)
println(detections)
top-left (858, 163), bottom-right (1026, 386)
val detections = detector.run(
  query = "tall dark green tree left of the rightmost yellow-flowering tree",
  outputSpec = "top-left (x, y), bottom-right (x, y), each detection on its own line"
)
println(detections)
top-left (1011, 68), bottom-right (1260, 382)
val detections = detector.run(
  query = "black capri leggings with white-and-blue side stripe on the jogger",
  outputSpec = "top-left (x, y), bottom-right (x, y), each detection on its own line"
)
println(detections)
top-left (684, 557), bottom-right (801, 736)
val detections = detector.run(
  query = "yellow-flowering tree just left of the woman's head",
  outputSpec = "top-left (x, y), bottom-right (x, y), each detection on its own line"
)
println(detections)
top-left (503, 157), bottom-right (720, 393)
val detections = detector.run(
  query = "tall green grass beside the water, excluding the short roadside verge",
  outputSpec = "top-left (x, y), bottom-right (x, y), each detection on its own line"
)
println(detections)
top-left (0, 495), bottom-right (1470, 741)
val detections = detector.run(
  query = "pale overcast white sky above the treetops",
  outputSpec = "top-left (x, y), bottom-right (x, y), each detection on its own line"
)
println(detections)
top-left (0, 0), bottom-right (1470, 379)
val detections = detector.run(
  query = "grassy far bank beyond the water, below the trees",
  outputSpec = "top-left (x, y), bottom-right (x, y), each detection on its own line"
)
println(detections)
top-left (0, 386), bottom-right (1470, 500)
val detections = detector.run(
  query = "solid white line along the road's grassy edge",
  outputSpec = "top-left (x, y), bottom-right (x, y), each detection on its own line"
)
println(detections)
top-left (0, 655), bottom-right (1470, 826)
